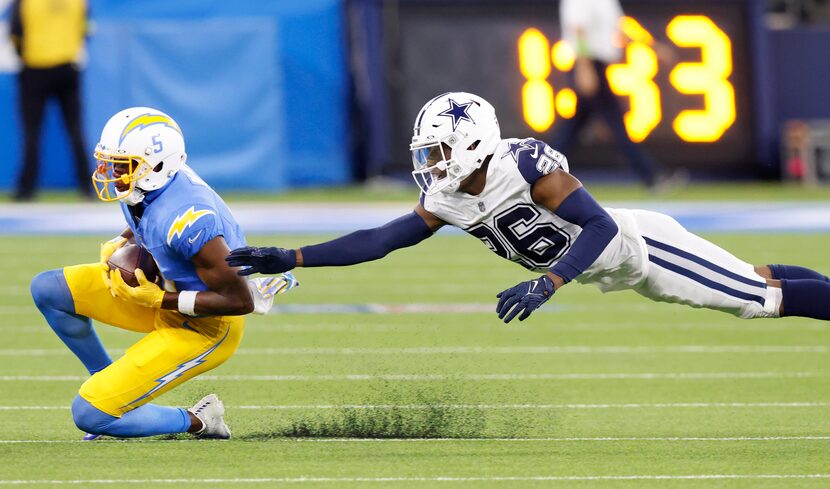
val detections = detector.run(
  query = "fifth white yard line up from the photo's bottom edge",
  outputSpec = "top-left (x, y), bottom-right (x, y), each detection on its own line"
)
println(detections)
top-left (0, 345), bottom-right (830, 356)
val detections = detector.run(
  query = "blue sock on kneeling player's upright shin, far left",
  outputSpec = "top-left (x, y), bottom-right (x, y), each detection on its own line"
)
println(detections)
top-left (30, 270), bottom-right (112, 374)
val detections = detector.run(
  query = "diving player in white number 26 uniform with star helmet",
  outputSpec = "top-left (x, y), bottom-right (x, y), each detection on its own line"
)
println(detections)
top-left (227, 92), bottom-right (830, 322)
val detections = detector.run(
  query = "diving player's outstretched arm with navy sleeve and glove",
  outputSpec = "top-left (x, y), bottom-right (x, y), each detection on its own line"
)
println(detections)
top-left (227, 205), bottom-right (444, 275)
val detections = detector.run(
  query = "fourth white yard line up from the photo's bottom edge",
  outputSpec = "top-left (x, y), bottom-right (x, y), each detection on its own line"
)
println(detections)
top-left (0, 372), bottom-right (826, 382)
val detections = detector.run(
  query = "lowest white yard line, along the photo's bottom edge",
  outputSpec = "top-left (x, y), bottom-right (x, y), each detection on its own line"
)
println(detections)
top-left (0, 474), bottom-right (830, 485)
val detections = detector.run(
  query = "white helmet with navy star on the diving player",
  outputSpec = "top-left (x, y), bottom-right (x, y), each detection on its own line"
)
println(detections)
top-left (409, 92), bottom-right (501, 195)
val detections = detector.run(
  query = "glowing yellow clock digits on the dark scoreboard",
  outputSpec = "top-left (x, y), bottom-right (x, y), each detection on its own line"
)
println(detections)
top-left (518, 15), bottom-right (735, 143)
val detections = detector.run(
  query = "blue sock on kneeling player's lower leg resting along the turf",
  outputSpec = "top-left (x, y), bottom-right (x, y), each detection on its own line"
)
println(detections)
top-left (72, 396), bottom-right (190, 438)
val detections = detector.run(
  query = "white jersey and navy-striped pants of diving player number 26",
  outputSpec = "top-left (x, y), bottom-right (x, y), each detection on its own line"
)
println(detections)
top-left (421, 139), bottom-right (781, 318)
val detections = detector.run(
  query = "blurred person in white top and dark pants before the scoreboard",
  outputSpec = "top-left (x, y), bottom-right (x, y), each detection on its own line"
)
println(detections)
top-left (552, 0), bottom-right (685, 191)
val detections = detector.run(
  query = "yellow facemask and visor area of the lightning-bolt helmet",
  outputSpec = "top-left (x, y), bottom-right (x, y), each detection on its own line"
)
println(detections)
top-left (92, 151), bottom-right (152, 202)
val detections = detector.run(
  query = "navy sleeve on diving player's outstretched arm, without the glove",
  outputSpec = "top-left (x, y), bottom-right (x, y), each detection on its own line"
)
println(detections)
top-left (300, 212), bottom-right (432, 267)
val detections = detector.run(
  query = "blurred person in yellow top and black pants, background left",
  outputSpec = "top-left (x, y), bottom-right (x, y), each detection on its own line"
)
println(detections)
top-left (11, 0), bottom-right (94, 201)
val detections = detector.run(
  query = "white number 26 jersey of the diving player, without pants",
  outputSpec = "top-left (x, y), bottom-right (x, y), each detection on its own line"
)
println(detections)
top-left (421, 138), bottom-right (641, 290)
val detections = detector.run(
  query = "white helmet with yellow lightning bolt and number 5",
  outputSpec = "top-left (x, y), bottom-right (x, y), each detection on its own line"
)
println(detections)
top-left (92, 107), bottom-right (187, 205)
